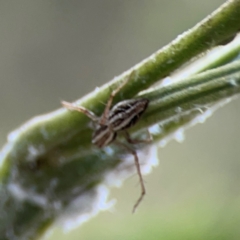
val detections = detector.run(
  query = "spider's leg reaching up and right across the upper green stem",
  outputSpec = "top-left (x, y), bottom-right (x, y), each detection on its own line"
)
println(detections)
top-left (99, 71), bottom-right (135, 125)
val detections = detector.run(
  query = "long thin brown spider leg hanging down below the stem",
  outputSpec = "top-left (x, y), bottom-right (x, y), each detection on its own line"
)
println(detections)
top-left (114, 141), bottom-right (146, 213)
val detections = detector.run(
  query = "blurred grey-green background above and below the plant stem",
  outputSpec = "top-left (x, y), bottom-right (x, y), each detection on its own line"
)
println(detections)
top-left (0, 0), bottom-right (240, 240)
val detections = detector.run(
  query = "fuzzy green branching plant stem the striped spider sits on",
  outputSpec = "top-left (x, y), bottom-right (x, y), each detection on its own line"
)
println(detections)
top-left (0, 0), bottom-right (240, 240)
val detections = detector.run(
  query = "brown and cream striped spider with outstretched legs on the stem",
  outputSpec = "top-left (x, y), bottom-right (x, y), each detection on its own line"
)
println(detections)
top-left (62, 73), bottom-right (151, 213)
